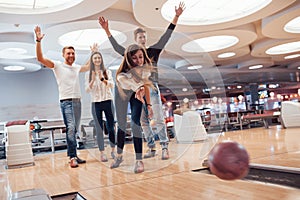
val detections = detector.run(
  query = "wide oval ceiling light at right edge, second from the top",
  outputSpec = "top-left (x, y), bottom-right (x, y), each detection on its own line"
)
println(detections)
top-left (266, 41), bottom-right (300, 55)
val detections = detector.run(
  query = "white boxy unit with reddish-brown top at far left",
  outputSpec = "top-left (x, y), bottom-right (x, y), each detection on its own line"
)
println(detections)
top-left (4, 120), bottom-right (34, 168)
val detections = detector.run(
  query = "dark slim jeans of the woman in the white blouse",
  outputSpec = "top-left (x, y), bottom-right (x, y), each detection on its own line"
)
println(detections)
top-left (92, 100), bottom-right (116, 151)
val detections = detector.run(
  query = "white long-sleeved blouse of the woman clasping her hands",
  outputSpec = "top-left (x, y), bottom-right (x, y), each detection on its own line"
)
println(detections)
top-left (85, 69), bottom-right (115, 102)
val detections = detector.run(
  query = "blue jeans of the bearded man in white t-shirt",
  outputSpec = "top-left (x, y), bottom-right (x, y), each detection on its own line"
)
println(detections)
top-left (60, 100), bottom-right (81, 158)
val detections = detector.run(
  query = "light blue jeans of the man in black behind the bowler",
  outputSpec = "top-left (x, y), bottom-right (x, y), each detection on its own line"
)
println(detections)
top-left (141, 84), bottom-right (169, 149)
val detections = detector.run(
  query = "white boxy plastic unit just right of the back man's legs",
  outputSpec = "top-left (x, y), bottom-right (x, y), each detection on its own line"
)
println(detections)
top-left (174, 111), bottom-right (207, 143)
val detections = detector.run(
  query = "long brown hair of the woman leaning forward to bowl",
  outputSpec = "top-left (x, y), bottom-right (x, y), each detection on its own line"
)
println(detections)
top-left (116, 44), bottom-right (154, 96)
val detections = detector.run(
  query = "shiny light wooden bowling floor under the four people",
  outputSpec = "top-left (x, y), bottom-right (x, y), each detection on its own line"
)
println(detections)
top-left (0, 125), bottom-right (300, 200)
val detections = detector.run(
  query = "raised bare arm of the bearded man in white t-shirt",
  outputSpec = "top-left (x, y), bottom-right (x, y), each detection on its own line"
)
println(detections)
top-left (34, 26), bottom-right (54, 68)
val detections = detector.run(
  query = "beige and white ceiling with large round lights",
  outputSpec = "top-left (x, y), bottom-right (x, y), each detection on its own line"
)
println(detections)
top-left (0, 0), bottom-right (300, 90)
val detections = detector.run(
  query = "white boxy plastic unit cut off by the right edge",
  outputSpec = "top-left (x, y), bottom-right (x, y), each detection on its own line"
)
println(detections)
top-left (281, 101), bottom-right (300, 128)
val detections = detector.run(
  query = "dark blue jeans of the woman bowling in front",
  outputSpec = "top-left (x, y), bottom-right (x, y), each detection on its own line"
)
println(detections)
top-left (115, 87), bottom-right (143, 160)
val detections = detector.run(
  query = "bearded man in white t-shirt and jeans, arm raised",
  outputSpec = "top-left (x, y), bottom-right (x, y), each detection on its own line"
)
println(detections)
top-left (34, 26), bottom-right (89, 168)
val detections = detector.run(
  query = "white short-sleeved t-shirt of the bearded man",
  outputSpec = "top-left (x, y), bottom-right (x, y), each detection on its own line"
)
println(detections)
top-left (53, 61), bottom-right (81, 100)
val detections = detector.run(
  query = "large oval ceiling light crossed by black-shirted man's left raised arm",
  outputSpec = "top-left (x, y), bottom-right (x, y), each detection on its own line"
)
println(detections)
top-left (58, 29), bottom-right (127, 50)
